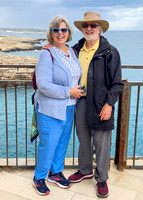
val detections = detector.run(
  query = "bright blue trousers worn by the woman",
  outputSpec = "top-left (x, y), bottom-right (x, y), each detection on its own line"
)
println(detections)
top-left (35, 104), bottom-right (75, 180)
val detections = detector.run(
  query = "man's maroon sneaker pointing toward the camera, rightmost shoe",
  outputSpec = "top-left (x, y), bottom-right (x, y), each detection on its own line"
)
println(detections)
top-left (97, 182), bottom-right (109, 198)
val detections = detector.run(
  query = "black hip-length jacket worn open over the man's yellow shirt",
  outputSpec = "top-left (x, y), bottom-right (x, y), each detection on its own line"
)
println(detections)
top-left (74, 36), bottom-right (123, 131)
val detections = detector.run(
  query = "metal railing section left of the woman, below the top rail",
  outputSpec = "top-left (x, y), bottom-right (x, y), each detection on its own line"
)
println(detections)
top-left (0, 80), bottom-right (37, 167)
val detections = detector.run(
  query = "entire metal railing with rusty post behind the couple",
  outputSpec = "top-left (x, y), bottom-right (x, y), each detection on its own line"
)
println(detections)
top-left (0, 65), bottom-right (143, 170)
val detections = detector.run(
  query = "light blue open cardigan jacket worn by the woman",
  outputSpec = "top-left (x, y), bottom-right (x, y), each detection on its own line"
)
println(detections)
top-left (35, 47), bottom-right (81, 120)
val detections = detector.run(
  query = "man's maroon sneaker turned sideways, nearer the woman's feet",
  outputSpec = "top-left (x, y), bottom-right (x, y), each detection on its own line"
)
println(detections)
top-left (68, 170), bottom-right (93, 183)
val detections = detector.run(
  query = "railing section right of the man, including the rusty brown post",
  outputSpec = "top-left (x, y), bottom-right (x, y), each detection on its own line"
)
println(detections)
top-left (115, 80), bottom-right (143, 170)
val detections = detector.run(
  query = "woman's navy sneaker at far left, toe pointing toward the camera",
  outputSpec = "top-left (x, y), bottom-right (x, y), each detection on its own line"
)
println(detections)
top-left (33, 176), bottom-right (50, 195)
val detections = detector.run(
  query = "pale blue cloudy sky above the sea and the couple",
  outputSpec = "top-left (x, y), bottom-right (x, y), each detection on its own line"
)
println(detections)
top-left (0, 0), bottom-right (143, 31)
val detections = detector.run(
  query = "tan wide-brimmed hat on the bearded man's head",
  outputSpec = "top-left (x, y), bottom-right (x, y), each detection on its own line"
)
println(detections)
top-left (74, 11), bottom-right (109, 33)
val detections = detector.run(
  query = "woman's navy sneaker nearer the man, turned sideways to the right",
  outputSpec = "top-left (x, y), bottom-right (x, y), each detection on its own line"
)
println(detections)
top-left (48, 171), bottom-right (71, 188)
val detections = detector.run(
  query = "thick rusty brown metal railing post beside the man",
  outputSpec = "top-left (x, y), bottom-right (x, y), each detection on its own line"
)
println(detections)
top-left (114, 80), bottom-right (130, 171)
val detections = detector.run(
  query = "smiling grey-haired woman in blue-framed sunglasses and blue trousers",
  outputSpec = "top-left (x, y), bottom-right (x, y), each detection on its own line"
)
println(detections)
top-left (33, 16), bottom-right (84, 195)
